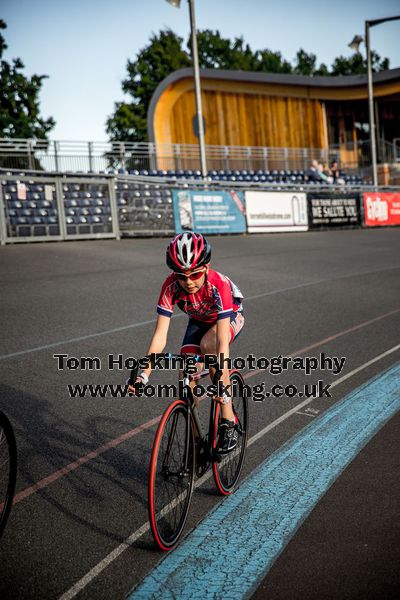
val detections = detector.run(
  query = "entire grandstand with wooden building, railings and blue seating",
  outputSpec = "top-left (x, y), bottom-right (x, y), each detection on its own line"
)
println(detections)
top-left (0, 69), bottom-right (400, 243)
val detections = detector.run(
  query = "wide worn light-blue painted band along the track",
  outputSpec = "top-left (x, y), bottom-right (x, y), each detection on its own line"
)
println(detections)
top-left (129, 364), bottom-right (400, 600)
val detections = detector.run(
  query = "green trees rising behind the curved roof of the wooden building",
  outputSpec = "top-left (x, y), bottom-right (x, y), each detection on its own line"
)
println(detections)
top-left (106, 29), bottom-right (389, 141)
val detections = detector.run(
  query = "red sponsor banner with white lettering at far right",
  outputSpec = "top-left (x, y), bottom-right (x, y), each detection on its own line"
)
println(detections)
top-left (363, 192), bottom-right (400, 227)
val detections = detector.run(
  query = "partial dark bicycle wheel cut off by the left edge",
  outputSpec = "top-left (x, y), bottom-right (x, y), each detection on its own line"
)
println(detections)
top-left (0, 411), bottom-right (17, 537)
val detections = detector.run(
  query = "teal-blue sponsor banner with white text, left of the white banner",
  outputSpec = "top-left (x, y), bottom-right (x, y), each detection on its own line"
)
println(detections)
top-left (172, 190), bottom-right (246, 234)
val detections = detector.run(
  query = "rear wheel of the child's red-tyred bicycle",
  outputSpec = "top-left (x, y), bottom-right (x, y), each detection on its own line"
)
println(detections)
top-left (213, 371), bottom-right (248, 496)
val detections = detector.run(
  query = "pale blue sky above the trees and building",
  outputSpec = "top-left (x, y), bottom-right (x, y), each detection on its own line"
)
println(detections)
top-left (0, 0), bottom-right (400, 142)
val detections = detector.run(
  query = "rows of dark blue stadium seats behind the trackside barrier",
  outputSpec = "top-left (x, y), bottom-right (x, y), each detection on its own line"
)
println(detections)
top-left (0, 170), bottom-right (362, 237)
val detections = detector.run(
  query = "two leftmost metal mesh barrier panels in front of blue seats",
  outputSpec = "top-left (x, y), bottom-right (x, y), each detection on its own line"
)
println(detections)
top-left (0, 174), bottom-right (120, 244)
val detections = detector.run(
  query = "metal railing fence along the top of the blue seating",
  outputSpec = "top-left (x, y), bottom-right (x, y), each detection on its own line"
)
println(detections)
top-left (0, 139), bottom-right (388, 173)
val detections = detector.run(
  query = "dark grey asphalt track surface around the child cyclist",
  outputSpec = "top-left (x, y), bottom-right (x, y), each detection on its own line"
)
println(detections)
top-left (0, 229), bottom-right (400, 599)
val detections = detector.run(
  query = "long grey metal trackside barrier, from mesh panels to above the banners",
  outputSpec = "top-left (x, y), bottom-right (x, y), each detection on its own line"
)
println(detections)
top-left (0, 172), bottom-right (399, 244)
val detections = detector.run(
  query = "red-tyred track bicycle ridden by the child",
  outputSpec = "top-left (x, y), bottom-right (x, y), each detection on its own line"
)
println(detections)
top-left (129, 353), bottom-right (248, 551)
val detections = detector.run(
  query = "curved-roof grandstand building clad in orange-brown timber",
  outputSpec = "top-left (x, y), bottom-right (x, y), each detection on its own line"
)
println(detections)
top-left (147, 68), bottom-right (400, 169)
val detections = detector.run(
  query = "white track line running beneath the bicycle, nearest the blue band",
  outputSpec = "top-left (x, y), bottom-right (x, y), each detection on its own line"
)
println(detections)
top-left (59, 344), bottom-right (400, 600)
